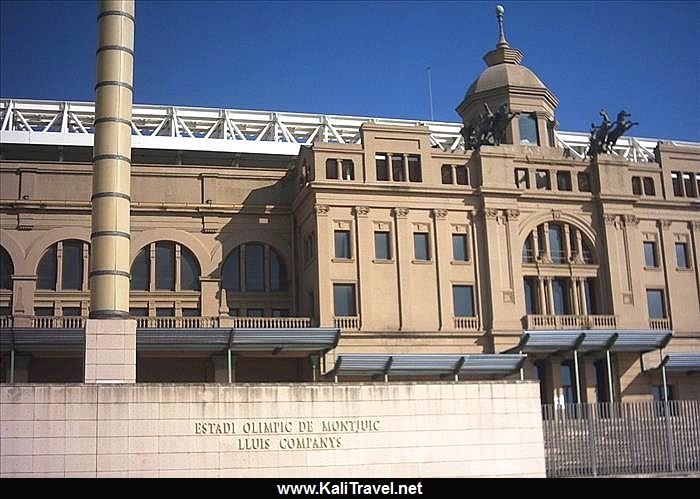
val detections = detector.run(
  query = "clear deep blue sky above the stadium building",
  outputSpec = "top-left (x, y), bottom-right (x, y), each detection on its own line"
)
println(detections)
top-left (0, 0), bottom-right (700, 141)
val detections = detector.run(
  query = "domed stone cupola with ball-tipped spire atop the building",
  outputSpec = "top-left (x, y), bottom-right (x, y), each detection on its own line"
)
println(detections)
top-left (457, 5), bottom-right (559, 147)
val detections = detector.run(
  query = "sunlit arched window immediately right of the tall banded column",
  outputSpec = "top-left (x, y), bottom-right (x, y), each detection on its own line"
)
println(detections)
top-left (131, 241), bottom-right (201, 291)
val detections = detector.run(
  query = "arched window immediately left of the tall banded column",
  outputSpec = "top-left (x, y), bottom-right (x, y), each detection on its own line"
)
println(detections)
top-left (36, 239), bottom-right (89, 291)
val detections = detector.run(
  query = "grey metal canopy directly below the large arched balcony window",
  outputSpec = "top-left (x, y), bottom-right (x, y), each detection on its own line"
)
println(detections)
top-left (504, 329), bottom-right (673, 353)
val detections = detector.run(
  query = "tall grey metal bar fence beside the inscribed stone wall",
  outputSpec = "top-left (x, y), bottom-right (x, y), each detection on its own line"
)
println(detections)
top-left (542, 400), bottom-right (700, 477)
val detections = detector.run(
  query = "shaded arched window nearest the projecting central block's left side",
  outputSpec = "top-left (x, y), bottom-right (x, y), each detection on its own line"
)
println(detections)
top-left (221, 243), bottom-right (287, 293)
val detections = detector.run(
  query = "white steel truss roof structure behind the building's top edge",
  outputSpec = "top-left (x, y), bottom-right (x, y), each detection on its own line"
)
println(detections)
top-left (0, 99), bottom-right (700, 163)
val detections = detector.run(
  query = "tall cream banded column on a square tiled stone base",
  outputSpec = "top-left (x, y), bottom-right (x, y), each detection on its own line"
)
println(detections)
top-left (85, 0), bottom-right (136, 383)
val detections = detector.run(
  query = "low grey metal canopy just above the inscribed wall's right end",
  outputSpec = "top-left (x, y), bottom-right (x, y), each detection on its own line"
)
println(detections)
top-left (327, 354), bottom-right (526, 380)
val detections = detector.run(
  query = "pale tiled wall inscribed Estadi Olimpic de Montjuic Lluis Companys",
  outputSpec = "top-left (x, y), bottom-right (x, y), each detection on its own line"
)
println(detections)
top-left (0, 381), bottom-right (545, 477)
